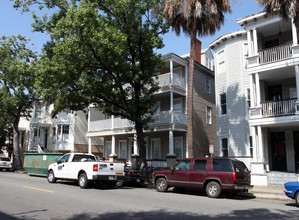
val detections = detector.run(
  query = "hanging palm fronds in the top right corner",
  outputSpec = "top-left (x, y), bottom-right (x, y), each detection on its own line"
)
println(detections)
top-left (256, 0), bottom-right (299, 21)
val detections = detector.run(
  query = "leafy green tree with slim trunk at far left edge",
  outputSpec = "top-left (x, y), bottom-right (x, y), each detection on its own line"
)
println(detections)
top-left (0, 35), bottom-right (37, 168)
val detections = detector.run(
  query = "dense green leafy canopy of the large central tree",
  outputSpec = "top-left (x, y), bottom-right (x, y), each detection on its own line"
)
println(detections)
top-left (15, 0), bottom-right (168, 125)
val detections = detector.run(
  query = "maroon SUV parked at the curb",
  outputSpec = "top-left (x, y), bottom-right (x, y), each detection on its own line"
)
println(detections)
top-left (153, 158), bottom-right (252, 198)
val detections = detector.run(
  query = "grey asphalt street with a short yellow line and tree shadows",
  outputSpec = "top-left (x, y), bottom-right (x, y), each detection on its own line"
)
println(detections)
top-left (0, 172), bottom-right (299, 220)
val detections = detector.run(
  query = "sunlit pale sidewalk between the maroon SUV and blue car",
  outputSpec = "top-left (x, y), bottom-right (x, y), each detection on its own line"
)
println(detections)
top-left (246, 185), bottom-right (295, 203)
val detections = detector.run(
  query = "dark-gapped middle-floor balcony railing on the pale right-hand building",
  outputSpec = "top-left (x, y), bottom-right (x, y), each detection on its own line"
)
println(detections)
top-left (262, 99), bottom-right (297, 117)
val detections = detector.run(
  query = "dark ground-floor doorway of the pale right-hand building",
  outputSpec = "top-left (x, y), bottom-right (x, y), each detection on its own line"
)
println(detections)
top-left (271, 132), bottom-right (287, 171)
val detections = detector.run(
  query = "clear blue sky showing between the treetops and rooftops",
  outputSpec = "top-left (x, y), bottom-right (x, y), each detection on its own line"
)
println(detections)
top-left (0, 0), bottom-right (263, 55)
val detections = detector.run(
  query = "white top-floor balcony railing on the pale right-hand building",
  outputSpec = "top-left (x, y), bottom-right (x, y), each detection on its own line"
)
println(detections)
top-left (259, 44), bottom-right (292, 64)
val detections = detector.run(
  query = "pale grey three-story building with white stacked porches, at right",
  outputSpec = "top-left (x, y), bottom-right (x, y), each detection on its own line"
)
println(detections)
top-left (210, 12), bottom-right (299, 185)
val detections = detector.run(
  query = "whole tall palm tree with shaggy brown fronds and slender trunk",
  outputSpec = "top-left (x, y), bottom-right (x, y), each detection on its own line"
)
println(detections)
top-left (164, 0), bottom-right (231, 157)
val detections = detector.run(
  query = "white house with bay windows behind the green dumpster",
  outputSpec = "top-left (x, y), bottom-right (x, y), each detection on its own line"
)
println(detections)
top-left (26, 102), bottom-right (103, 156)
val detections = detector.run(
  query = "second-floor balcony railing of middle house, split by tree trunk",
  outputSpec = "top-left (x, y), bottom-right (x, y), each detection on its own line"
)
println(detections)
top-left (89, 111), bottom-right (187, 132)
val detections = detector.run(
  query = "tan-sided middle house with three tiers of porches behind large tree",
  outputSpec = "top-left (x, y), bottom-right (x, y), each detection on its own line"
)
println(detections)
top-left (87, 41), bottom-right (216, 165)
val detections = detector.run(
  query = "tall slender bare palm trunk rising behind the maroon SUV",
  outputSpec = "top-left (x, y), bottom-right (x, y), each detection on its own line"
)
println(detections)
top-left (187, 19), bottom-right (196, 157)
